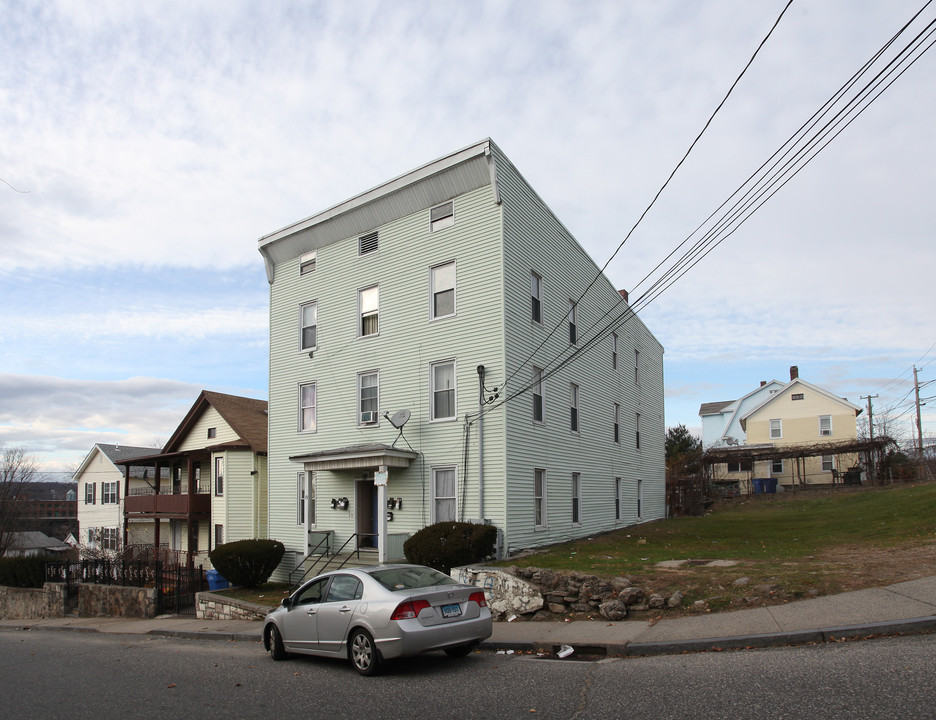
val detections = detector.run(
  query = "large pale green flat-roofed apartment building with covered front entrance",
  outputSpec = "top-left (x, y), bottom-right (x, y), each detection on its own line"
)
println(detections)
top-left (259, 139), bottom-right (665, 573)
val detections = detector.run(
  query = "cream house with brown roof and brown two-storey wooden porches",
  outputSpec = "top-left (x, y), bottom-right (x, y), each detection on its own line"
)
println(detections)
top-left (119, 390), bottom-right (268, 568)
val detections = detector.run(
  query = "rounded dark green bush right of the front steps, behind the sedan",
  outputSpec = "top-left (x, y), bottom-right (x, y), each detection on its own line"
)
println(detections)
top-left (403, 522), bottom-right (497, 573)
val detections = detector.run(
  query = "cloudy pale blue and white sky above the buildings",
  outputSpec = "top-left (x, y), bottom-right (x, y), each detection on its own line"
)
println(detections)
top-left (0, 0), bottom-right (936, 478)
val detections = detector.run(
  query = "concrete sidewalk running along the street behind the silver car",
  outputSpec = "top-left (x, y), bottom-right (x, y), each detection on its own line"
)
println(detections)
top-left (0, 576), bottom-right (936, 655)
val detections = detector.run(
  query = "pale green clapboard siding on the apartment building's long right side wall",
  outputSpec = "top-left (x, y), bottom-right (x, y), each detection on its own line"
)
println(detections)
top-left (495, 145), bottom-right (665, 549)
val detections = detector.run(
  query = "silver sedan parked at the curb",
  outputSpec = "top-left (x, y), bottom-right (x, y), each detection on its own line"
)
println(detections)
top-left (263, 565), bottom-right (491, 675)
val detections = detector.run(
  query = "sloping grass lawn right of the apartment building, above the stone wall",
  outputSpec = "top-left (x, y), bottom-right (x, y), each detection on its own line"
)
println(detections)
top-left (502, 483), bottom-right (936, 609)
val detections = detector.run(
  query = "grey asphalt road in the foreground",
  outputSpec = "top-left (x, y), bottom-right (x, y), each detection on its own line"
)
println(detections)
top-left (0, 630), bottom-right (936, 720)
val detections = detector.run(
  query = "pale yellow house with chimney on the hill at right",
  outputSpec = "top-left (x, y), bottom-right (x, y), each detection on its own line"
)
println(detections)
top-left (741, 372), bottom-right (861, 486)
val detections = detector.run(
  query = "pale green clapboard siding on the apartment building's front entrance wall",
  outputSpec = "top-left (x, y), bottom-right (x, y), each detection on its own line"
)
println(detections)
top-left (269, 181), bottom-right (503, 564)
